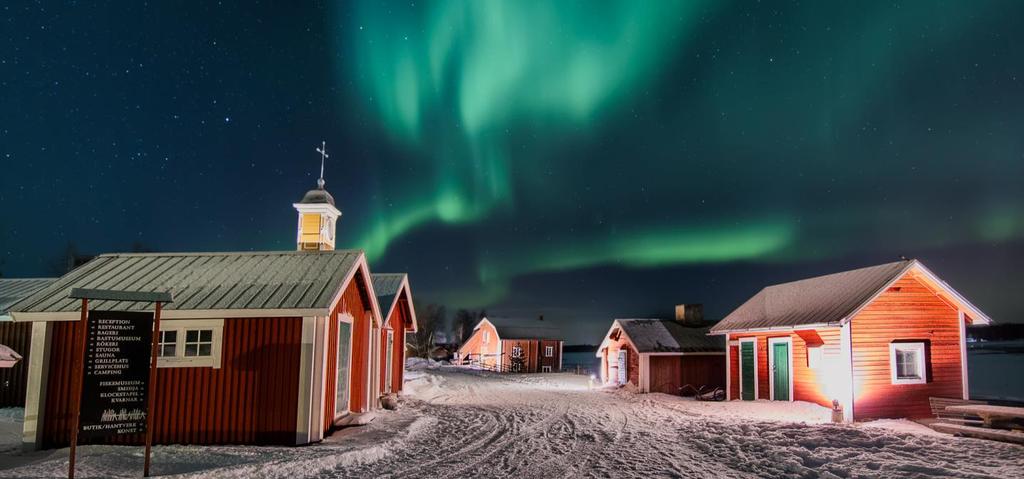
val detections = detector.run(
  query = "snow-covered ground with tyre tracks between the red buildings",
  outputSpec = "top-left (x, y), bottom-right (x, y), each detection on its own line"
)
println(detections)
top-left (0, 362), bottom-right (1024, 479)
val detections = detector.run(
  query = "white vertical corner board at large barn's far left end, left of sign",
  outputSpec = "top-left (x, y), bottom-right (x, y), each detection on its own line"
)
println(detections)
top-left (22, 322), bottom-right (53, 450)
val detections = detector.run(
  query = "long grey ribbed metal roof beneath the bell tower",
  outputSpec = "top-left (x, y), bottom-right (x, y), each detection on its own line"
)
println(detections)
top-left (10, 250), bottom-right (362, 314)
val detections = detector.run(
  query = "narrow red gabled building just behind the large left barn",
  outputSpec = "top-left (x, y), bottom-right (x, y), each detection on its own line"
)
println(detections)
top-left (372, 273), bottom-right (416, 394)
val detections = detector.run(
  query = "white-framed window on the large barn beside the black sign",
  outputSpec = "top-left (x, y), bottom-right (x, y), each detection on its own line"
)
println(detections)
top-left (157, 319), bottom-right (224, 368)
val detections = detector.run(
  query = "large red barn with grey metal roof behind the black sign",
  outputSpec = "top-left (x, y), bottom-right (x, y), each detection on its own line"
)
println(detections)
top-left (11, 250), bottom-right (381, 447)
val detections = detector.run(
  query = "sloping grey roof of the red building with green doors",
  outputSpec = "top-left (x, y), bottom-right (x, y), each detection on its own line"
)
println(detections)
top-left (711, 260), bottom-right (915, 333)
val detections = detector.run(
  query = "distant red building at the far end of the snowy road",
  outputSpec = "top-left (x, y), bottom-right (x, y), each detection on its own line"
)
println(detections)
top-left (456, 316), bottom-right (563, 373)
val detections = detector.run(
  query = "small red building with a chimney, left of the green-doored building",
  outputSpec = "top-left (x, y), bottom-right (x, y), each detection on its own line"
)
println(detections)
top-left (597, 305), bottom-right (725, 394)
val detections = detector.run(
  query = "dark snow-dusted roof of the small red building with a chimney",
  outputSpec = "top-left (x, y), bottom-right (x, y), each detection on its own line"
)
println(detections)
top-left (615, 319), bottom-right (725, 353)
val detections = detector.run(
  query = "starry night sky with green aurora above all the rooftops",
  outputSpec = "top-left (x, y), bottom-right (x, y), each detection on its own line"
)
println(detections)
top-left (0, 0), bottom-right (1024, 342)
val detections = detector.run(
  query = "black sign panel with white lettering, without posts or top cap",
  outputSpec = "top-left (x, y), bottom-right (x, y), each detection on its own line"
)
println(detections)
top-left (79, 311), bottom-right (153, 438)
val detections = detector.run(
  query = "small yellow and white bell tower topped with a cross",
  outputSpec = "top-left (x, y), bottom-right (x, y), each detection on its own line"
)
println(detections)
top-left (292, 142), bottom-right (341, 251)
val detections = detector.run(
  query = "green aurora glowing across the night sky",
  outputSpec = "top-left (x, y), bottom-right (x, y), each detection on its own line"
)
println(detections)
top-left (338, 1), bottom-right (1024, 303)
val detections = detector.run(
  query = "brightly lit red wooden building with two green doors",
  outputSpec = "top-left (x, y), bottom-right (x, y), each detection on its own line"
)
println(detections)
top-left (712, 260), bottom-right (991, 421)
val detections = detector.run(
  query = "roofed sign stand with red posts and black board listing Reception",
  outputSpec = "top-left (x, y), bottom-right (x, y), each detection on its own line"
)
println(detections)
top-left (68, 289), bottom-right (171, 479)
